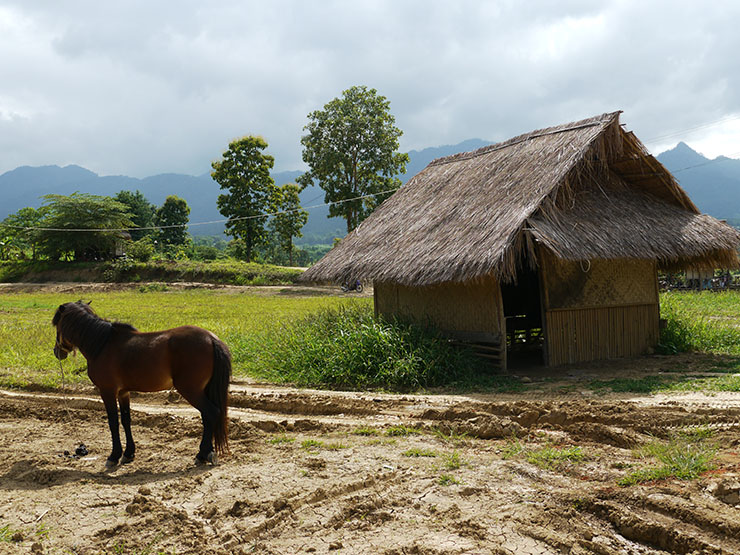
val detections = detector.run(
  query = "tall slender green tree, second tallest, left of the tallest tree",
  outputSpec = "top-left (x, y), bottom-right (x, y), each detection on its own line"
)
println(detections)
top-left (211, 135), bottom-right (277, 262)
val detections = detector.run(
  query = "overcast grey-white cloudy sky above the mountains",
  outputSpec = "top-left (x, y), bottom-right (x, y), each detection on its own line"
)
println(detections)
top-left (0, 0), bottom-right (740, 177)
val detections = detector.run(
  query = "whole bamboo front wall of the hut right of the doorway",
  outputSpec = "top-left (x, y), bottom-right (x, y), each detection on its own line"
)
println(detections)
top-left (541, 254), bottom-right (660, 366)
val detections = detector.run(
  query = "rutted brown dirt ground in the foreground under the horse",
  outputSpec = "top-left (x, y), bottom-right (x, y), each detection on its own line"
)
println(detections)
top-left (0, 384), bottom-right (740, 555)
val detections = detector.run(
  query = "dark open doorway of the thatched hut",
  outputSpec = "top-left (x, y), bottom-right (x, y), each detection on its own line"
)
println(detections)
top-left (501, 268), bottom-right (545, 367)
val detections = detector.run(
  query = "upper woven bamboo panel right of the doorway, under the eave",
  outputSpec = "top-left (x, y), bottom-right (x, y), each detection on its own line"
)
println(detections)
top-left (544, 254), bottom-right (658, 309)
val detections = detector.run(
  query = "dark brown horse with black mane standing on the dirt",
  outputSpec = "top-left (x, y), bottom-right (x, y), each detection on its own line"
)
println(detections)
top-left (51, 301), bottom-right (231, 467)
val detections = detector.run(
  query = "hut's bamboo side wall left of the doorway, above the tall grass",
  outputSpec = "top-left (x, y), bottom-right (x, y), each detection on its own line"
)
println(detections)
top-left (374, 278), bottom-right (503, 334)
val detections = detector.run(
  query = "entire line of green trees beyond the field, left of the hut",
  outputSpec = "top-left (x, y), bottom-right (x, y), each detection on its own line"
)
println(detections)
top-left (0, 87), bottom-right (408, 266)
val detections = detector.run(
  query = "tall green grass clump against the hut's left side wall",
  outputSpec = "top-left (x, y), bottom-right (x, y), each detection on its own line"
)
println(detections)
top-left (251, 305), bottom-right (480, 391)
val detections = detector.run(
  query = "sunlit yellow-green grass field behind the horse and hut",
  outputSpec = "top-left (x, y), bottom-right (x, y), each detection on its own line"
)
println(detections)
top-left (0, 287), bottom-right (740, 394)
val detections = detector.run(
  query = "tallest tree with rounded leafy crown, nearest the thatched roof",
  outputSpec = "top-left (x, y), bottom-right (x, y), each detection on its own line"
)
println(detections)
top-left (298, 86), bottom-right (409, 232)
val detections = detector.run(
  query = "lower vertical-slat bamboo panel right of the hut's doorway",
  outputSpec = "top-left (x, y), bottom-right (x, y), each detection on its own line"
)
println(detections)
top-left (545, 304), bottom-right (659, 366)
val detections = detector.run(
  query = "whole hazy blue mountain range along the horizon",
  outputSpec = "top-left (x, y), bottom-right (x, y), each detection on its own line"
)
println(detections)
top-left (0, 139), bottom-right (740, 242)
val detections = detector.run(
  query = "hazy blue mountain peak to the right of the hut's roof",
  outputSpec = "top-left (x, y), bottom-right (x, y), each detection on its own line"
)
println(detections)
top-left (657, 143), bottom-right (740, 220)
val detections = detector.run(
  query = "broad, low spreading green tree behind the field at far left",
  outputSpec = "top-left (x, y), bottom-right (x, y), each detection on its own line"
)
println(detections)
top-left (38, 193), bottom-right (133, 260)
